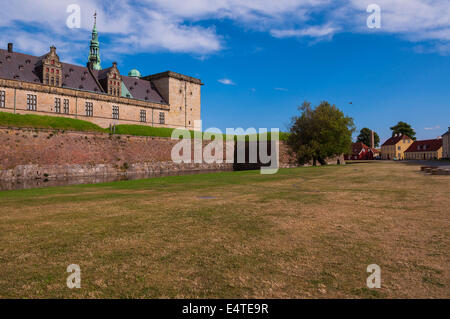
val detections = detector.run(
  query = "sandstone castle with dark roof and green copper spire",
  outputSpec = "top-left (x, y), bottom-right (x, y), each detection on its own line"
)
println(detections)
top-left (0, 13), bottom-right (203, 129)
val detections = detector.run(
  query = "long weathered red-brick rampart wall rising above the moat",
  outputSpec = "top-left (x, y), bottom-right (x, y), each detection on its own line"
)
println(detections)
top-left (0, 128), bottom-right (233, 181)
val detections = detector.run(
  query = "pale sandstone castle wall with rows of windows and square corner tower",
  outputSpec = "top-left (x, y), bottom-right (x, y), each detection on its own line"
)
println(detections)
top-left (0, 78), bottom-right (201, 129)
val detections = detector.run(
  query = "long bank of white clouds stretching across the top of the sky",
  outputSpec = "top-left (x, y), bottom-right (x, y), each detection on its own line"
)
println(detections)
top-left (0, 0), bottom-right (450, 60)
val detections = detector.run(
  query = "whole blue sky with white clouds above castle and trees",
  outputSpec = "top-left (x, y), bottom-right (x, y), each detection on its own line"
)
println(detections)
top-left (0, 0), bottom-right (450, 141)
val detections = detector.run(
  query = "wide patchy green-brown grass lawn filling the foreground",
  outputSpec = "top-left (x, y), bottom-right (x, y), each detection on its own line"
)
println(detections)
top-left (0, 161), bottom-right (450, 298)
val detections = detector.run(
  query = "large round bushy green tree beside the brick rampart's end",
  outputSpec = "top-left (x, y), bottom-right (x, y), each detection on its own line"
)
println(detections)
top-left (287, 101), bottom-right (355, 165)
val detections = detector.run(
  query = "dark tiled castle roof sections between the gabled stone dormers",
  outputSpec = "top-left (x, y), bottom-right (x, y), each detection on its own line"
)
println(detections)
top-left (0, 49), bottom-right (167, 104)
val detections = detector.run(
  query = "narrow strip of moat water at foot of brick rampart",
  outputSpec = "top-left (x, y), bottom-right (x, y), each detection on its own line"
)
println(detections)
top-left (0, 170), bottom-right (226, 191)
